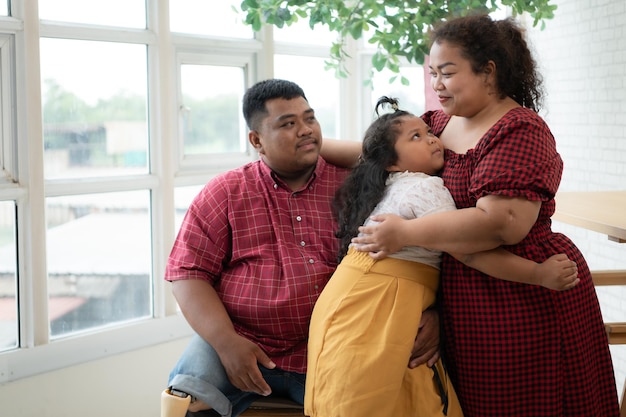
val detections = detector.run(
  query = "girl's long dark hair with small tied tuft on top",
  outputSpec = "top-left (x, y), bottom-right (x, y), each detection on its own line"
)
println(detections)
top-left (333, 97), bottom-right (413, 261)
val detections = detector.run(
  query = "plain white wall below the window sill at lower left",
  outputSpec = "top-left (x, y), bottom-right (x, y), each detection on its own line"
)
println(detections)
top-left (0, 338), bottom-right (188, 417)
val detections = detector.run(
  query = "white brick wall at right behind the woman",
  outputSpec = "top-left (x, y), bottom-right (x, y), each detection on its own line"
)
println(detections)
top-left (529, 0), bottom-right (626, 392)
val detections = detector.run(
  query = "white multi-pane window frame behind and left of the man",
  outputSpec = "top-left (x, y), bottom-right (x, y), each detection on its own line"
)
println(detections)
top-left (0, 0), bottom-right (358, 384)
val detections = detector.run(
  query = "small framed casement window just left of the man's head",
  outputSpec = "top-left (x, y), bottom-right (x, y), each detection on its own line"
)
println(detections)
top-left (178, 51), bottom-right (255, 174)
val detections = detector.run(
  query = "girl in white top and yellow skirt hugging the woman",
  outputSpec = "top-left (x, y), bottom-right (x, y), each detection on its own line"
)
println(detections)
top-left (305, 97), bottom-right (578, 417)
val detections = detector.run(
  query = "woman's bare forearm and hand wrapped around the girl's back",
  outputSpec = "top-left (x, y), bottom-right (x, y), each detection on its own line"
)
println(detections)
top-left (352, 195), bottom-right (541, 259)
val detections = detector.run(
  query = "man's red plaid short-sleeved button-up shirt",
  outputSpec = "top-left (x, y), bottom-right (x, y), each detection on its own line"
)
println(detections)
top-left (165, 158), bottom-right (347, 373)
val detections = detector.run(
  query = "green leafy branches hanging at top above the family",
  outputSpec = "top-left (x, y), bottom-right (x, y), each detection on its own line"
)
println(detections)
top-left (234, 0), bottom-right (557, 82)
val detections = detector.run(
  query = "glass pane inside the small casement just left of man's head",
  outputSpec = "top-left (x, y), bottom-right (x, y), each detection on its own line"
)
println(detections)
top-left (180, 65), bottom-right (247, 155)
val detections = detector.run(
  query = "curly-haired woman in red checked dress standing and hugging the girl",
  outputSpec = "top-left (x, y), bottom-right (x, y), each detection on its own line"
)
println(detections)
top-left (324, 16), bottom-right (619, 417)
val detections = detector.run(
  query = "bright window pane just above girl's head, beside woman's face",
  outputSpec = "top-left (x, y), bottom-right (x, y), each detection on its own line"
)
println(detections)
top-left (371, 66), bottom-right (426, 117)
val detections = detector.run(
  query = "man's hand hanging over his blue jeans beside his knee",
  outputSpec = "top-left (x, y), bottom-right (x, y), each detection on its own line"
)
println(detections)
top-left (218, 335), bottom-right (276, 396)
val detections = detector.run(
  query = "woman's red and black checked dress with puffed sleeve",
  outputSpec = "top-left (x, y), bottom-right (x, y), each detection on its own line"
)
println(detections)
top-left (424, 108), bottom-right (619, 417)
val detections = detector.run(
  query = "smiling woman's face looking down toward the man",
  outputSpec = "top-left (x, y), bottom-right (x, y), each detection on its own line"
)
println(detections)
top-left (429, 42), bottom-right (493, 117)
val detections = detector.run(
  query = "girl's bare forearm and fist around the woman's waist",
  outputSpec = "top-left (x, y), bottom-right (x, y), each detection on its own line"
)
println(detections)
top-left (451, 248), bottom-right (580, 291)
